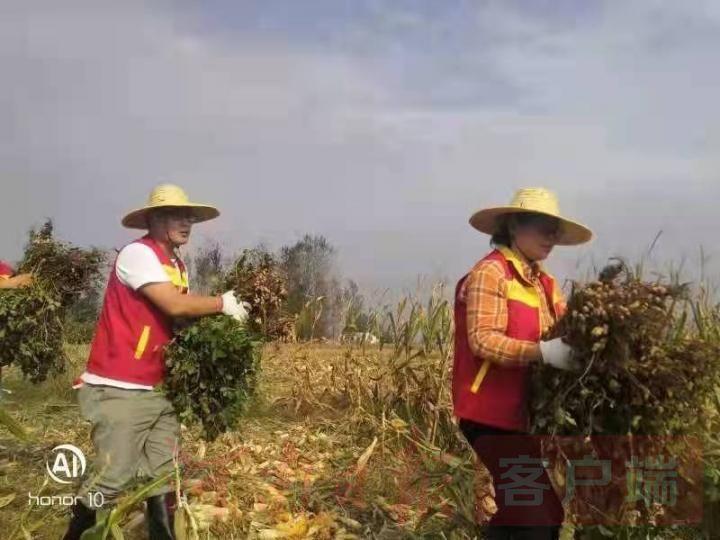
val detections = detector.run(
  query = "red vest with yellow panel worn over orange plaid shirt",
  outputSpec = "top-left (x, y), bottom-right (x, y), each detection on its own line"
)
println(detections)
top-left (452, 248), bottom-right (562, 432)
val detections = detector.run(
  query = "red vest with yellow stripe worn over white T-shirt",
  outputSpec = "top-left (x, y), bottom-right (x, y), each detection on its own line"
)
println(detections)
top-left (87, 236), bottom-right (188, 386)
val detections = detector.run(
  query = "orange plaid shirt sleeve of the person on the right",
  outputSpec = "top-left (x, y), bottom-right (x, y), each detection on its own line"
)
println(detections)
top-left (461, 261), bottom-right (538, 366)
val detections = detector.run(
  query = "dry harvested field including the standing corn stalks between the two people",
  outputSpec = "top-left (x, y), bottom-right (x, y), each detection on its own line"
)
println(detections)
top-left (0, 280), bottom-right (720, 540)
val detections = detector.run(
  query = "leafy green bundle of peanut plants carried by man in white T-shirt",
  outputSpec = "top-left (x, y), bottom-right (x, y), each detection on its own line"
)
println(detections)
top-left (164, 250), bottom-right (278, 441)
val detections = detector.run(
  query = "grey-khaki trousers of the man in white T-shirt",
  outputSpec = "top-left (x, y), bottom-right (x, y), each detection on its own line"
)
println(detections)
top-left (78, 384), bottom-right (180, 507)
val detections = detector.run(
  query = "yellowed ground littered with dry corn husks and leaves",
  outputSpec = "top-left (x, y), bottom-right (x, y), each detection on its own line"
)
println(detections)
top-left (0, 344), bottom-right (484, 539)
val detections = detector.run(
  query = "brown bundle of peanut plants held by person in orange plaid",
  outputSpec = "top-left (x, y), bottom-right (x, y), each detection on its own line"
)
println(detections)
top-left (532, 263), bottom-right (720, 435)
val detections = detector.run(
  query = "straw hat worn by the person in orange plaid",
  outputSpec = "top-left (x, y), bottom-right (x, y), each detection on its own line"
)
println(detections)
top-left (470, 188), bottom-right (592, 246)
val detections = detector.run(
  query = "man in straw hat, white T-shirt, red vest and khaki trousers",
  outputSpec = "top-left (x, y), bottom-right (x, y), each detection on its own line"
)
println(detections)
top-left (64, 184), bottom-right (247, 540)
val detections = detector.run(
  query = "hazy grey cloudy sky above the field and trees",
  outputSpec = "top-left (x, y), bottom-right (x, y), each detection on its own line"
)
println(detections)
top-left (0, 0), bottom-right (720, 296)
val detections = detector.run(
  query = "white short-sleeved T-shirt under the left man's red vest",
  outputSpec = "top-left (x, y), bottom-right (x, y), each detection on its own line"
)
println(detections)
top-left (80, 242), bottom-right (186, 390)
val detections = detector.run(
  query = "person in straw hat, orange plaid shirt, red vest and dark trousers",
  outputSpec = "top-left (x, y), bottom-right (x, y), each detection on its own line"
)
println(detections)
top-left (452, 188), bottom-right (592, 539)
